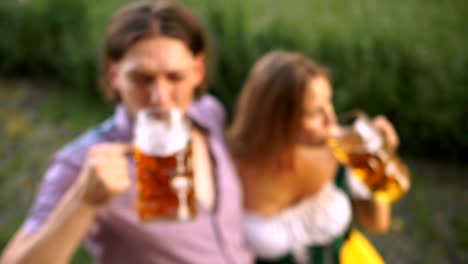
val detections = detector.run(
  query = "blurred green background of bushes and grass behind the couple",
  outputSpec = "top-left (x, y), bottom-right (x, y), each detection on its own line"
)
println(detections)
top-left (0, 0), bottom-right (468, 263)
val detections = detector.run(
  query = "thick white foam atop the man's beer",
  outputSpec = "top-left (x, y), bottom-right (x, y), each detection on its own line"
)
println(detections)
top-left (133, 109), bottom-right (191, 157)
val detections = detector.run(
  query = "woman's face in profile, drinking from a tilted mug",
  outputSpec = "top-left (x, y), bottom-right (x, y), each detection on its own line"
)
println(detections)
top-left (300, 76), bottom-right (336, 145)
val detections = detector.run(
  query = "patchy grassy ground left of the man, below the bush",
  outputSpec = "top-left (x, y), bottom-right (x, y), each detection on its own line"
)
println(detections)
top-left (0, 82), bottom-right (103, 263)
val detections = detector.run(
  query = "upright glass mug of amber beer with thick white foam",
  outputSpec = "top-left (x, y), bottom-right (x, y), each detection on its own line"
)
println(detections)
top-left (134, 109), bottom-right (196, 221)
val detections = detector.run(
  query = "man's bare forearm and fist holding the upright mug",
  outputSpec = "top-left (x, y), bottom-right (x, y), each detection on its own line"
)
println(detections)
top-left (0, 144), bottom-right (129, 264)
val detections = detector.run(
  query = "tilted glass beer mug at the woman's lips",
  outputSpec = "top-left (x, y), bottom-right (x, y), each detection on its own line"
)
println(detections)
top-left (328, 111), bottom-right (411, 202)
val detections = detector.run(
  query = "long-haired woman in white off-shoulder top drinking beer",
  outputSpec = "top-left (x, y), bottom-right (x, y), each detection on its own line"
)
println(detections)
top-left (228, 51), bottom-right (397, 263)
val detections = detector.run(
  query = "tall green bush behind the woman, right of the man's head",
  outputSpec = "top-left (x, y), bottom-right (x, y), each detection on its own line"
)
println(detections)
top-left (205, 1), bottom-right (468, 160)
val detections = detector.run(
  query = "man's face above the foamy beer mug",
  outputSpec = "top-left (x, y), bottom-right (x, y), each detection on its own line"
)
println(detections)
top-left (108, 37), bottom-right (205, 116)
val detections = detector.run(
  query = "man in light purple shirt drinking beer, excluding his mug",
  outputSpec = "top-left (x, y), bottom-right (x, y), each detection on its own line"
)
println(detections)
top-left (0, 1), bottom-right (251, 264)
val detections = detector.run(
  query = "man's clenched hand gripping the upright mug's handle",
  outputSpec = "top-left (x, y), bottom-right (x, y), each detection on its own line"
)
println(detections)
top-left (78, 143), bottom-right (131, 206)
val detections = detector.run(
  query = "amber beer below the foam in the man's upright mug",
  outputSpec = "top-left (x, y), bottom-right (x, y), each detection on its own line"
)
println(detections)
top-left (134, 142), bottom-right (196, 221)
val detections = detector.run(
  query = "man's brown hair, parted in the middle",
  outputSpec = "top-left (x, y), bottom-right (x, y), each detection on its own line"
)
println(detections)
top-left (101, 0), bottom-right (212, 102)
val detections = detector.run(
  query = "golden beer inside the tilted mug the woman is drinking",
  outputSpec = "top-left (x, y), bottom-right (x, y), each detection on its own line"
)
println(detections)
top-left (328, 113), bottom-right (410, 202)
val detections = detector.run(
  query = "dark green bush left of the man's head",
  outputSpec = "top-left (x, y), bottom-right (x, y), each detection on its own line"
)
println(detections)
top-left (0, 0), bottom-right (96, 96)
